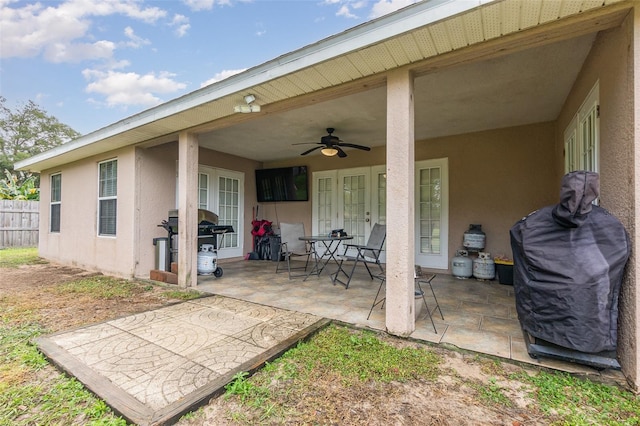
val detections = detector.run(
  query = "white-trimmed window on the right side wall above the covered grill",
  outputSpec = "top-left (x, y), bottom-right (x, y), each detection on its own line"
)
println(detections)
top-left (564, 83), bottom-right (600, 173)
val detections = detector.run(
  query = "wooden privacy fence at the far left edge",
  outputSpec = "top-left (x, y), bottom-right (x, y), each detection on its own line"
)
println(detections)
top-left (0, 200), bottom-right (40, 248)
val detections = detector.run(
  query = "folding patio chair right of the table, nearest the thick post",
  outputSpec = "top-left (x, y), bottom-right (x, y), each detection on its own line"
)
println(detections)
top-left (331, 223), bottom-right (387, 289)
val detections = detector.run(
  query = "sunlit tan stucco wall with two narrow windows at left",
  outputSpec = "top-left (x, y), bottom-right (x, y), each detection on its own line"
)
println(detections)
top-left (38, 148), bottom-right (135, 277)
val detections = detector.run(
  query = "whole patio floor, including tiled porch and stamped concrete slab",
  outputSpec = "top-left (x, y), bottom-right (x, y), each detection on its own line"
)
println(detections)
top-left (36, 261), bottom-right (625, 425)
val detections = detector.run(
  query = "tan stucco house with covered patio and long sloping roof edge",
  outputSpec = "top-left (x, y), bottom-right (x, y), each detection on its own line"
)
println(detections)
top-left (16, 0), bottom-right (640, 386)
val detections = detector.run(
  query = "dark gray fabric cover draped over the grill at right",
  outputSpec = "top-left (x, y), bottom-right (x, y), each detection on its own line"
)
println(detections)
top-left (510, 171), bottom-right (630, 353)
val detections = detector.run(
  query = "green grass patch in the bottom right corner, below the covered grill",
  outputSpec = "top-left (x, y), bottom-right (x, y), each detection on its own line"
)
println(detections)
top-left (514, 372), bottom-right (640, 426)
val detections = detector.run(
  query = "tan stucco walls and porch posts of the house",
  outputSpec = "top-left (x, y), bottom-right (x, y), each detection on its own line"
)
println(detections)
top-left (28, 1), bottom-right (640, 386)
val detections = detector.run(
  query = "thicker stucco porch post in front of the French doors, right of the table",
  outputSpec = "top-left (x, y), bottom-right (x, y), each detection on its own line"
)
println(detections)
top-left (386, 70), bottom-right (415, 336)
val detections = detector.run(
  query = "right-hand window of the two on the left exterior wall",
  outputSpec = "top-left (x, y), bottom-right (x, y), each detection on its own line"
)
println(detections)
top-left (98, 160), bottom-right (118, 236)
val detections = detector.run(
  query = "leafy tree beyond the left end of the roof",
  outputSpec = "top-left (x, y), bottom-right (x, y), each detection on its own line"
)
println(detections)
top-left (0, 96), bottom-right (80, 176)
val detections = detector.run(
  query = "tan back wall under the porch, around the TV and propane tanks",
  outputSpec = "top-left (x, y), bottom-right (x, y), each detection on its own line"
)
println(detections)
top-left (260, 123), bottom-right (560, 270)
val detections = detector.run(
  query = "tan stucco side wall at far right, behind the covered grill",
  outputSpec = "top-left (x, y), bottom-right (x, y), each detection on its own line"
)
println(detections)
top-left (556, 12), bottom-right (640, 390)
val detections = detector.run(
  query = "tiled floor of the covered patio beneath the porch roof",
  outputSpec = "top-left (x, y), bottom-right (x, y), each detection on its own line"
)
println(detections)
top-left (198, 260), bottom-right (625, 383)
